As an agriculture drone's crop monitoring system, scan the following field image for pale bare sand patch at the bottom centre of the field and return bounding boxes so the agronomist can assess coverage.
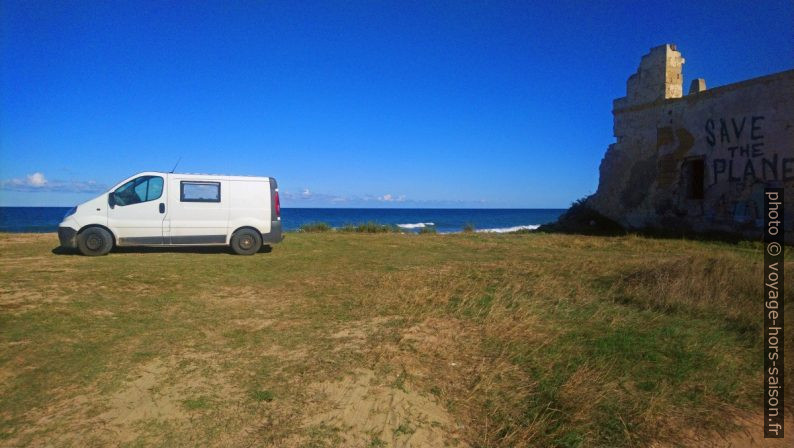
[286,316,470,447]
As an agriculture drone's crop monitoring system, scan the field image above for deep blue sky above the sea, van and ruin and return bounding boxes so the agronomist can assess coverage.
[0,0,794,207]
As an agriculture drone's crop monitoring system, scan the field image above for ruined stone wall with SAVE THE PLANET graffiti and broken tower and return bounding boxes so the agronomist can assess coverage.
[587,45,794,241]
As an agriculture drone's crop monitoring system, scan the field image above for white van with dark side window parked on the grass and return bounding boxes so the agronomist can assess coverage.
[58,172,283,255]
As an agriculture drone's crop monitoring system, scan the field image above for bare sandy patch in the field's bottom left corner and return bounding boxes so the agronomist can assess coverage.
[4,352,244,446]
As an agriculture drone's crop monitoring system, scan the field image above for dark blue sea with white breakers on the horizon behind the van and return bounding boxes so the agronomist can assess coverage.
[0,207,565,233]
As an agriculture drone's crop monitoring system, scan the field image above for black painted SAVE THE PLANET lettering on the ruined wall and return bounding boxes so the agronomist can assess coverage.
[704,115,794,184]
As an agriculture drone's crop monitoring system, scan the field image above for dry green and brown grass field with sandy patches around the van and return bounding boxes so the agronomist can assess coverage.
[0,232,794,447]
